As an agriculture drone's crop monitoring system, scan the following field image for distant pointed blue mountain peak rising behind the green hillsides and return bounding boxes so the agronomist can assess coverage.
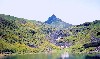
[44,14,72,29]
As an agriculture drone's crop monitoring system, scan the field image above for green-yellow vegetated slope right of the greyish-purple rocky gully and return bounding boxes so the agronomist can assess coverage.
[66,20,100,53]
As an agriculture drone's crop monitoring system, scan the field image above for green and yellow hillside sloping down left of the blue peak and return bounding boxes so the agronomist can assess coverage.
[0,14,59,53]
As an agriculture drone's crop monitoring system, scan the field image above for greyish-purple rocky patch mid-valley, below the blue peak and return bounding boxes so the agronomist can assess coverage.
[47,30,71,47]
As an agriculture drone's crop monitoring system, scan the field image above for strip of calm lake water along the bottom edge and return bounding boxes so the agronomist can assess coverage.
[1,53,100,59]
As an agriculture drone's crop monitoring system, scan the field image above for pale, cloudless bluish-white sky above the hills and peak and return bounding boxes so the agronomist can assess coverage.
[0,0,100,25]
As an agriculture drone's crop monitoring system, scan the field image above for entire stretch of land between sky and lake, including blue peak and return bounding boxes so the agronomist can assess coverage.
[0,14,100,53]
